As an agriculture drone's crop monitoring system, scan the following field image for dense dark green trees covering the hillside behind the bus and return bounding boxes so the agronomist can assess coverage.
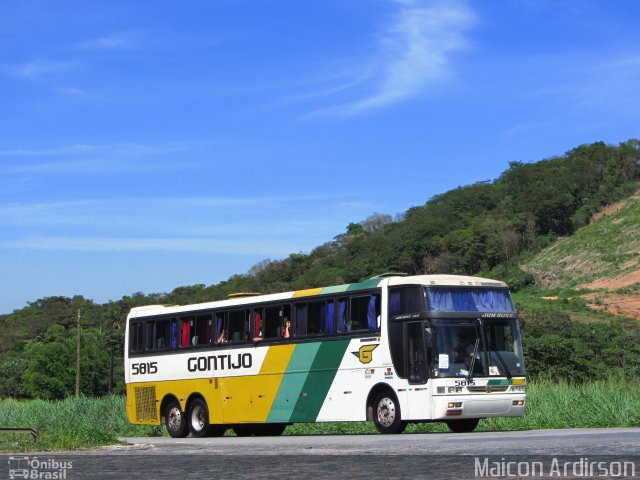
[0,140,640,398]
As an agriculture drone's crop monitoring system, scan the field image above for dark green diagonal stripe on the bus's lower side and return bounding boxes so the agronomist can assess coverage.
[290,340,349,422]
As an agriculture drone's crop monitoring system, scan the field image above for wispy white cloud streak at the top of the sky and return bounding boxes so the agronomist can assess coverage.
[312,0,474,116]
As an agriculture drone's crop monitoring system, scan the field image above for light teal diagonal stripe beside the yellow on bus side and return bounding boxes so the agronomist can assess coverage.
[267,342,321,423]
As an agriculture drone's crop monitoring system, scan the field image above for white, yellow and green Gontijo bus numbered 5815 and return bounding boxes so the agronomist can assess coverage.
[124,274,525,437]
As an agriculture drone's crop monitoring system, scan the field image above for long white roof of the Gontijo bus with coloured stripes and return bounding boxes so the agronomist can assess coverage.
[129,274,507,317]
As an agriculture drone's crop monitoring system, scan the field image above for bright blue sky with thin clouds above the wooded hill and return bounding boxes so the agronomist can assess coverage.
[0,0,640,313]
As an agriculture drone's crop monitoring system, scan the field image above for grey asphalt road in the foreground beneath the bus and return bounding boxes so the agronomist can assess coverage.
[0,428,640,480]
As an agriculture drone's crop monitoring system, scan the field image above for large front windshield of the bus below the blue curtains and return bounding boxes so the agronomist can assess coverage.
[432,319,525,377]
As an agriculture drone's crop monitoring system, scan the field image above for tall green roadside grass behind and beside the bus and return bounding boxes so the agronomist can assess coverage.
[0,378,640,452]
